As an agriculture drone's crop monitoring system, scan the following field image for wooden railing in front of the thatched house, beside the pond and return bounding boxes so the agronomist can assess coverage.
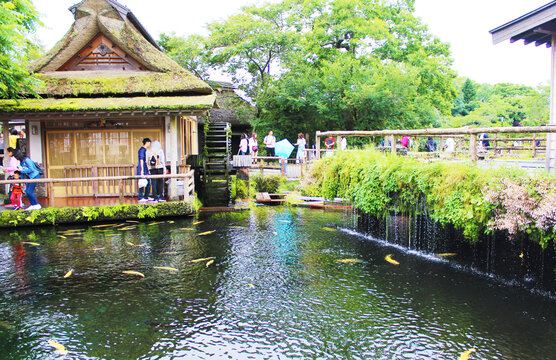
[0,170,195,205]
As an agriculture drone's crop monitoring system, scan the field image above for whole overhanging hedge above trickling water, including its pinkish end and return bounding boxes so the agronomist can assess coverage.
[302,149,556,246]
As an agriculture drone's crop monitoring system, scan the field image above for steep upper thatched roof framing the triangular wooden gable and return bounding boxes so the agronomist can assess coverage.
[30,0,212,97]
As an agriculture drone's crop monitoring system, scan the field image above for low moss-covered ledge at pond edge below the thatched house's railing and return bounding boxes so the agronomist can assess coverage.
[0,200,196,228]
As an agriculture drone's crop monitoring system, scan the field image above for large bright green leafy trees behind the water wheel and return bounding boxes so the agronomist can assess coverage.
[161,0,455,139]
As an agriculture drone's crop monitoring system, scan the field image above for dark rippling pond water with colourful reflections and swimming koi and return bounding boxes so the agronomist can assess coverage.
[0,208,556,360]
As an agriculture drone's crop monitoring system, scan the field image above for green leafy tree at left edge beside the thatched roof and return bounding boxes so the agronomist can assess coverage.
[0,0,38,98]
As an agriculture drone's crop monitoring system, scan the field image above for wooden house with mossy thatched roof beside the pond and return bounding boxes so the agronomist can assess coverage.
[0,0,215,197]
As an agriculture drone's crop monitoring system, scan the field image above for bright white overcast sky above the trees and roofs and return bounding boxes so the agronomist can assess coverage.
[34,0,551,86]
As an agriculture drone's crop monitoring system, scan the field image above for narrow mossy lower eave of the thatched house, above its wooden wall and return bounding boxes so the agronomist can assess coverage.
[0,95,215,113]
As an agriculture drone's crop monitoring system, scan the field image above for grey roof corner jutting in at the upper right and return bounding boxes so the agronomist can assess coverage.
[490,1,556,47]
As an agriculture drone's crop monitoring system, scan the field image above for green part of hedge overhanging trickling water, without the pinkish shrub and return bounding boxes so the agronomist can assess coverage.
[303,150,556,241]
